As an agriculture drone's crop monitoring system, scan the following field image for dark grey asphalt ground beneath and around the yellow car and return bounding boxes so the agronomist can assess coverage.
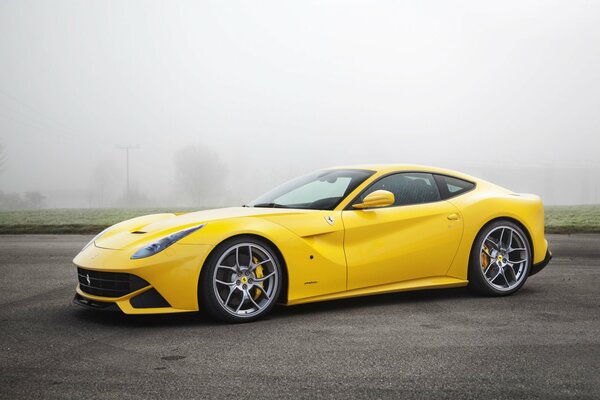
[0,235,600,400]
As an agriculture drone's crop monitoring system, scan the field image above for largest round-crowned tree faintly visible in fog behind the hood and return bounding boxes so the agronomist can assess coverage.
[175,145,227,205]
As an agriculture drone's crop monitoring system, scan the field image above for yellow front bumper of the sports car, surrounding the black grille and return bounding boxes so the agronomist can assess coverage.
[73,244,213,314]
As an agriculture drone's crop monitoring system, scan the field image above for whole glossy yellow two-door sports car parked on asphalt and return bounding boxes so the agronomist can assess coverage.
[73,165,552,322]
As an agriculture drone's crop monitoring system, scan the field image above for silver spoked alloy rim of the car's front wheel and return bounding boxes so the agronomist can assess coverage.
[213,243,279,317]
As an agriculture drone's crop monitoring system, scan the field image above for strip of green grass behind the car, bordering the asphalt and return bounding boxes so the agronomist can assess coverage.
[0,204,600,234]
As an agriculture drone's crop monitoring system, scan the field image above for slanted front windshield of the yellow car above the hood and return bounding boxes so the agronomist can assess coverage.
[247,169,373,210]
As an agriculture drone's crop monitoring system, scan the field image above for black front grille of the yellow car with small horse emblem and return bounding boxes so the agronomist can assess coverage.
[77,268,149,297]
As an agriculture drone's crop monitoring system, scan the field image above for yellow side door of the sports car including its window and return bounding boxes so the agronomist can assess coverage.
[342,172,463,290]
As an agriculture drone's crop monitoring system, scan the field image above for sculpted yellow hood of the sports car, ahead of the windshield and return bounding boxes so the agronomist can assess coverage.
[94,207,318,250]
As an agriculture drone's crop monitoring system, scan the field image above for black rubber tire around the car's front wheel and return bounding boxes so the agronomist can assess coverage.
[198,236,283,323]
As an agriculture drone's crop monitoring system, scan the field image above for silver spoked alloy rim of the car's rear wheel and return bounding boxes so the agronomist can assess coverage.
[479,225,529,292]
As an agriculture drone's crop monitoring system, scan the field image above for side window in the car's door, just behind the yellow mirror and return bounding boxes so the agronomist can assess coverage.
[356,172,441,206]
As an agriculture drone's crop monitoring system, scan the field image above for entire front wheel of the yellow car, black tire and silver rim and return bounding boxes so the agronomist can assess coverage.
[199,237,282,322]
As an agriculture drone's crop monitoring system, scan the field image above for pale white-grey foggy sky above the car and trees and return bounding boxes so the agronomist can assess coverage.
[0,0,600,207]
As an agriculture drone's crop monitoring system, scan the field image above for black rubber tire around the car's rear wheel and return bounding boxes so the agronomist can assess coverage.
[468,220,533,296]
